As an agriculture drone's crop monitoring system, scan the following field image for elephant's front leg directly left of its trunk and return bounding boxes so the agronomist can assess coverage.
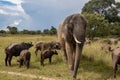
[65,42,74,74]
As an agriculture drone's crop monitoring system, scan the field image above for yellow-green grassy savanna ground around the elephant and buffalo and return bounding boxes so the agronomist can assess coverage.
[0,35,120,80]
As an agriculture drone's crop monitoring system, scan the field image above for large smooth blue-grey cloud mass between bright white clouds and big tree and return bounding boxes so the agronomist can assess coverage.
[22,0,88,30]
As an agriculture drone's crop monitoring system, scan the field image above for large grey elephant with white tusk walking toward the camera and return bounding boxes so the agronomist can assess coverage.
[58,14,86,80]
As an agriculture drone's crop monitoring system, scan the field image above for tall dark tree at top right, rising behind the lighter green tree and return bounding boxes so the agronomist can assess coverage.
[82,0,120,23]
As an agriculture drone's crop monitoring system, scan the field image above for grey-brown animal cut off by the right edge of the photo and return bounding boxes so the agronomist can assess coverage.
[111,47,120,78]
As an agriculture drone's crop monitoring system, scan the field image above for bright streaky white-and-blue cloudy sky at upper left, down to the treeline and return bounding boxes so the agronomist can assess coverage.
[0,0,31,29]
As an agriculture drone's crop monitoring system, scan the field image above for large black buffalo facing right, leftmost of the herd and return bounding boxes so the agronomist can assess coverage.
[5,42,33,66]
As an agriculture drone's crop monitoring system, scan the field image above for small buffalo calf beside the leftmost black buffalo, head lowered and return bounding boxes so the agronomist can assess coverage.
[18,50,31,69]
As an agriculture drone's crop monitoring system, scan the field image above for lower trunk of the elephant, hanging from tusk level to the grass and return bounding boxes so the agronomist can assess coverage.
[73,43,83,80]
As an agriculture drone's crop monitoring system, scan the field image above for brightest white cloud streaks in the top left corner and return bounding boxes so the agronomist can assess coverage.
[0,0,30,19]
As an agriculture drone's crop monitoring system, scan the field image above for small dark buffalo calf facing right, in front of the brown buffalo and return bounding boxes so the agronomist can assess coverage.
[40,50,58,66]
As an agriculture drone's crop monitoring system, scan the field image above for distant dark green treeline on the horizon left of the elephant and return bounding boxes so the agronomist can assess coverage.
[0,26,57,35]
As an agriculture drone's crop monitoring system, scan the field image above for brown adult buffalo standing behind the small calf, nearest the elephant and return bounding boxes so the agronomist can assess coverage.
[35,41,61,56]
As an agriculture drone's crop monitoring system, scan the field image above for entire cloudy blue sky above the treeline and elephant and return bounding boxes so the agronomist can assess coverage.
[0,0,89,30]
